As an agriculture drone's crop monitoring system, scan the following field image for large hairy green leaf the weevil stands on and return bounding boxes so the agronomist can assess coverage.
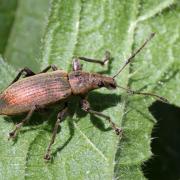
[0,0,180,179]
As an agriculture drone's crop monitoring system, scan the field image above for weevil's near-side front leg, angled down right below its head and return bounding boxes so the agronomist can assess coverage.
[81,99,122,135]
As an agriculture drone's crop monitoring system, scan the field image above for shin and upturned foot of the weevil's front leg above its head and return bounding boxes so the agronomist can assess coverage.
[74,51,111,65]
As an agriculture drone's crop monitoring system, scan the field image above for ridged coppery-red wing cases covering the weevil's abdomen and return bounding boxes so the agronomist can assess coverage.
[0,70,71,115]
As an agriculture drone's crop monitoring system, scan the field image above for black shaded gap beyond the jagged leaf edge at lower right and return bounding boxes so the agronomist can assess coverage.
[142,101,180,180]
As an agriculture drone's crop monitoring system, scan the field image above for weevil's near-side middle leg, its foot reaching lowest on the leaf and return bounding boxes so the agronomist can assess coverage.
[44,105,68,160]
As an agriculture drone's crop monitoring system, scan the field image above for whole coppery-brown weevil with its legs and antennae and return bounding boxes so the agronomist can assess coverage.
[0,33,166,160]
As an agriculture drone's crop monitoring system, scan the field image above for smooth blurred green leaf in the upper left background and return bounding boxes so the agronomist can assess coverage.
[0,0,49,71]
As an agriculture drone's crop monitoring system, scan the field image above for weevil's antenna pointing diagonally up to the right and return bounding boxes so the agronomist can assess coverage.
[113,33,155,79]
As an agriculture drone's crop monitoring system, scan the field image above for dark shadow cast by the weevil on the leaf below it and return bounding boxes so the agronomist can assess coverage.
[5,92,121,160]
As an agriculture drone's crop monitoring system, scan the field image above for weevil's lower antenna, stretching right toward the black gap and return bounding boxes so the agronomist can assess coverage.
[118,85,168,103]
